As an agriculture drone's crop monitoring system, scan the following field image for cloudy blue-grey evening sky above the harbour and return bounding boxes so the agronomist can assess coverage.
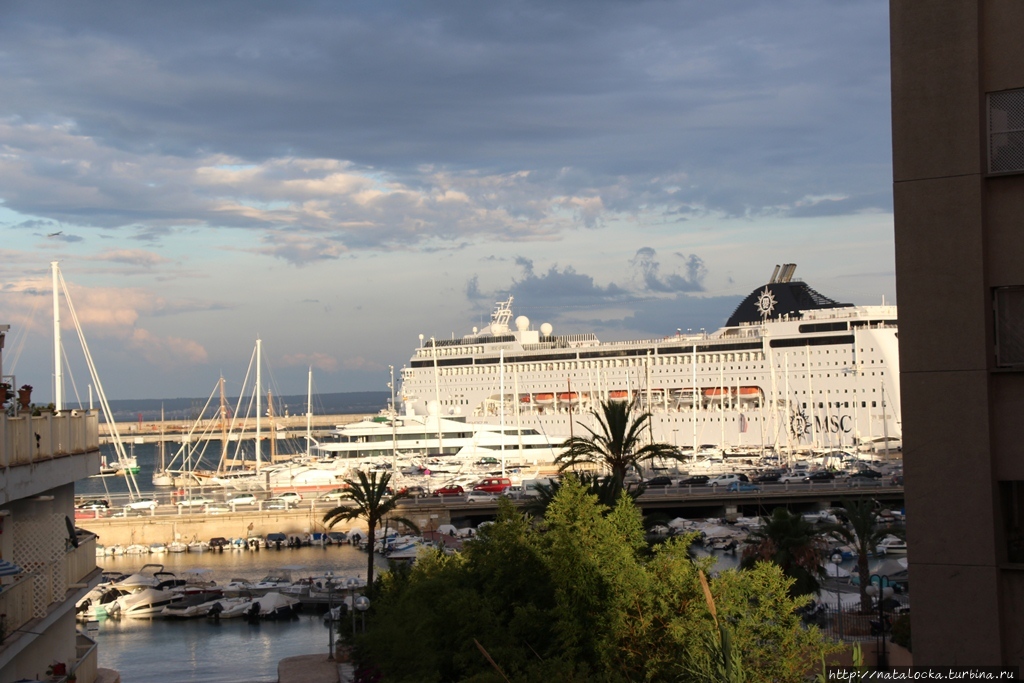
[0,0,895,401]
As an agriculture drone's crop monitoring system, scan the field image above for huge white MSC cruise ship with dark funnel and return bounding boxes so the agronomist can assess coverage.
[397,263,901,456]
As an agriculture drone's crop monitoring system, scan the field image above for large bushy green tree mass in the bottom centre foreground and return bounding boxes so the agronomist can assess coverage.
[359,477,831,683]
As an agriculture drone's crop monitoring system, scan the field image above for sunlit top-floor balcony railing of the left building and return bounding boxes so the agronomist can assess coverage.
[0,411,99,467]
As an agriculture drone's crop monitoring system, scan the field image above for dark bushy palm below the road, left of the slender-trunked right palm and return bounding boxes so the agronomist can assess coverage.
[739,508,825,597]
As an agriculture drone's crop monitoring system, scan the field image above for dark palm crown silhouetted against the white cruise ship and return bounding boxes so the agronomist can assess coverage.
[555,400,679,488]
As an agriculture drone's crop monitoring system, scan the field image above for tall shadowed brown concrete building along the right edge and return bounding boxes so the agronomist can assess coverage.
[890,0,1024,667]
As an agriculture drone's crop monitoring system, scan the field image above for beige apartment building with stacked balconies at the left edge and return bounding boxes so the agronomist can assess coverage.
[0,326,100,683]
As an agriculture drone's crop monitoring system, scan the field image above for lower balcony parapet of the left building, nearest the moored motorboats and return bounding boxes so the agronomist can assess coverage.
[0,536,96,647]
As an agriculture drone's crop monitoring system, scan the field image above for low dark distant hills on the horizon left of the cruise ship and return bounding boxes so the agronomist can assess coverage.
[97,391,391,422]
